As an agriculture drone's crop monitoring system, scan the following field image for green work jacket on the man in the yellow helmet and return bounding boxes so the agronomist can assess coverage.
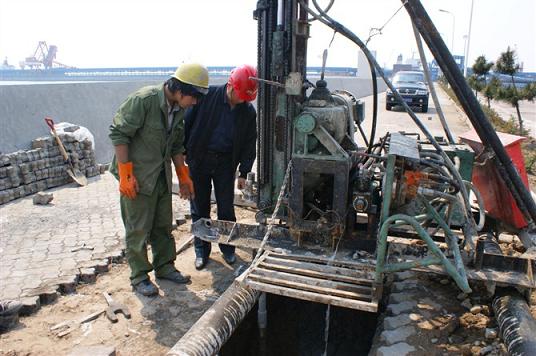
[109,84,185,195]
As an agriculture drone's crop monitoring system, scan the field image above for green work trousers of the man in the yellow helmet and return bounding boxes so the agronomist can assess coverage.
[121,173,177,285]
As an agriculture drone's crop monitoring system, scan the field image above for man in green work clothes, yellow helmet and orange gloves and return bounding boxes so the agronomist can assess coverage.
[109,63,208,296]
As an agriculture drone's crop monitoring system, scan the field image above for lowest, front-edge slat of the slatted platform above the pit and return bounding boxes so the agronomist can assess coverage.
[246,280,378,313]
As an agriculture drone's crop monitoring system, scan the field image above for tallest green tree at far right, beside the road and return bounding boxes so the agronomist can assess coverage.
[495,46,524,134]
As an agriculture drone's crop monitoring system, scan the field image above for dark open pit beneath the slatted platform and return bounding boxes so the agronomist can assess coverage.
[219,294,378,356]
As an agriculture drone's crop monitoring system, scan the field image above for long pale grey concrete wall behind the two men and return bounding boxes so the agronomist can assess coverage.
[0,77,385,163]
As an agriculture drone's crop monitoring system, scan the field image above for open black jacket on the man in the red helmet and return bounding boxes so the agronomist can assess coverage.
[184,84,257,178]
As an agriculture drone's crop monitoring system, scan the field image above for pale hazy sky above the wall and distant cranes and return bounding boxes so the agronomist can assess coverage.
[0,0,536,72]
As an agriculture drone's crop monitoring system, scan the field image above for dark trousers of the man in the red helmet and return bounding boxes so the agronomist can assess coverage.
[190,153,236,258]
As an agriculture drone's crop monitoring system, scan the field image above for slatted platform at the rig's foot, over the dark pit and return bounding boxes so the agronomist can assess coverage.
[241,251,381,313]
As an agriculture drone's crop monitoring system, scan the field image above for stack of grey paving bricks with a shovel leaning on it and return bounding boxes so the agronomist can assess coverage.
[0,134,106,204]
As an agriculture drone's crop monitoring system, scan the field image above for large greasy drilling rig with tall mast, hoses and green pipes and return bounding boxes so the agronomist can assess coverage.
[172,0,536,355]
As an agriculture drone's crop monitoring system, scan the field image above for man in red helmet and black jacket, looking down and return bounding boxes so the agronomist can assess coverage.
[184,65,257,270]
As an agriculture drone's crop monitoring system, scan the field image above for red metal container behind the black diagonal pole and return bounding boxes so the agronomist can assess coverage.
[460,130,529,229]
